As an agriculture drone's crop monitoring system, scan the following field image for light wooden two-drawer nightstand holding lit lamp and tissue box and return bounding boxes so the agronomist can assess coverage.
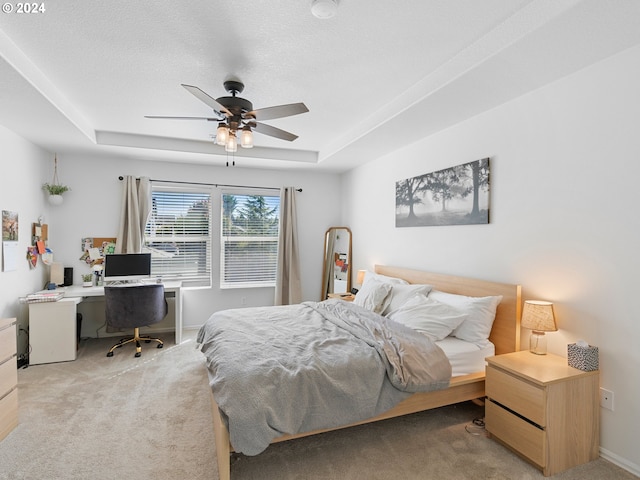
[485,351,600,476]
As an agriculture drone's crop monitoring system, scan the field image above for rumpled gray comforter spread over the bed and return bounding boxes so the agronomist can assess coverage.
[198,300,451,455]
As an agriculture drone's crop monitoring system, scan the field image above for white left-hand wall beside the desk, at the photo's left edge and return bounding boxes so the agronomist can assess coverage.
[0,126,53,353]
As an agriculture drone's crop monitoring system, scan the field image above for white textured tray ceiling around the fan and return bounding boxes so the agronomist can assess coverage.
[0,0,640,171]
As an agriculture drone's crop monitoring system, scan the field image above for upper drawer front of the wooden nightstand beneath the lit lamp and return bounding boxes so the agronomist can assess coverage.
[485,365,546,427]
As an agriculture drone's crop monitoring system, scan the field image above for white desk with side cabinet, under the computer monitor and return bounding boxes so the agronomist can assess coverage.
[29,282,182,365]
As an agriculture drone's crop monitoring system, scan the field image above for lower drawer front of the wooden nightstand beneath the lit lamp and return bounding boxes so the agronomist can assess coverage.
[485,401,546,467]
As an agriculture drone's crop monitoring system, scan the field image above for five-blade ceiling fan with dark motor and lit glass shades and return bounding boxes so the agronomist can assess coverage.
[145,80,309,152]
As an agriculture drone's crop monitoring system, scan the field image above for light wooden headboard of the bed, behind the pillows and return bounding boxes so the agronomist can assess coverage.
[375,265,522,355]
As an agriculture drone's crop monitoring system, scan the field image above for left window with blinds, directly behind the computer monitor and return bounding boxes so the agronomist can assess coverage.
[145,186,211,285]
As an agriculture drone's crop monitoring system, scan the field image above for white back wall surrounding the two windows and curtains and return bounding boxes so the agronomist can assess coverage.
[45,154,341,336]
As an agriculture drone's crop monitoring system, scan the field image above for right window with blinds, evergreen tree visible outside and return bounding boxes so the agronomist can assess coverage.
[220,193,280,288]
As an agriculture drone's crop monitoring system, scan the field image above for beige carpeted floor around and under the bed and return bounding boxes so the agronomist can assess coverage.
[0,332,637,480]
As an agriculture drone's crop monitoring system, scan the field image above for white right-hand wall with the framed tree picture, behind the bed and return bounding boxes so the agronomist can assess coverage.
[343,47,640,474]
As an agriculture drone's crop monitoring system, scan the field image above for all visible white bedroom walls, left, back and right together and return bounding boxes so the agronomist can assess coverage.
[0,36,640,474]
